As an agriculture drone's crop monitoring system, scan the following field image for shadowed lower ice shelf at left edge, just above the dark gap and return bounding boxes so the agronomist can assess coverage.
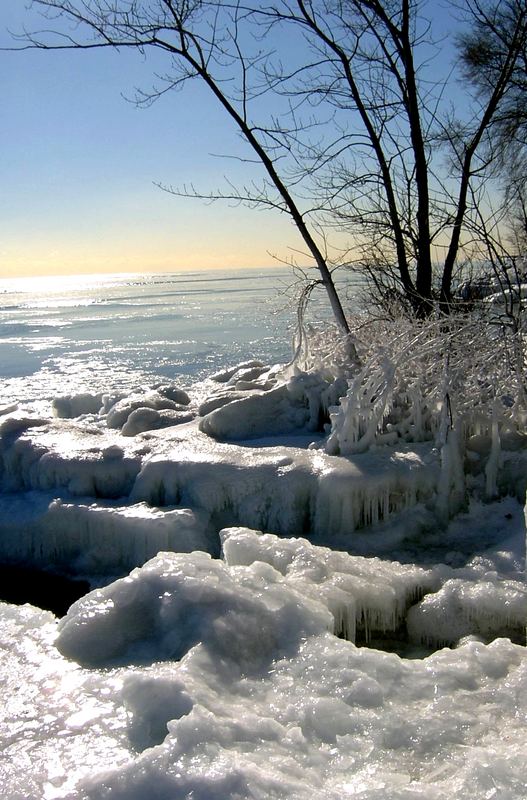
[0,492,212,577]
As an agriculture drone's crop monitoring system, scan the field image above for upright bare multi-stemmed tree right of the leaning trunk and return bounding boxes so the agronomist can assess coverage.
[245,0,527,317]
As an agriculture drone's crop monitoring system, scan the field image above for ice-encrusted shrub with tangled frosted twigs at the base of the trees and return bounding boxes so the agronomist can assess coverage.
[300,308,527,495]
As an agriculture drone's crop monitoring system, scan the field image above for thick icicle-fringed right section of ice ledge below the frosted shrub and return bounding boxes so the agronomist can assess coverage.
[130,431,438,538]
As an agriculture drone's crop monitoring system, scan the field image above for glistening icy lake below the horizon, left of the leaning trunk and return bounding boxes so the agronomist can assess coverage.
[0,269,300,404]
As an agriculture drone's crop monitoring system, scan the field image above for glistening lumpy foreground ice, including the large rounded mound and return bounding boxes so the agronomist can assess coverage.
[0,530,527,800]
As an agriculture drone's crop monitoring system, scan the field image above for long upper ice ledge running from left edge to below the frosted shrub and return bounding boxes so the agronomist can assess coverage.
[0,412,437,537]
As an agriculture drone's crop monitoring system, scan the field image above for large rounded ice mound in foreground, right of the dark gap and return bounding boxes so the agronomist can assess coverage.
[57,552,331,671]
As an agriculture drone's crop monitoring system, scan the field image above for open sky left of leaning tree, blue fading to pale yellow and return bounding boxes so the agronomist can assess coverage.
[0,0,462,277]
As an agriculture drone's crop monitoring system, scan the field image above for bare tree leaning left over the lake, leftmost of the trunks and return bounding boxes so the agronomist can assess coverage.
[13,0,368,362]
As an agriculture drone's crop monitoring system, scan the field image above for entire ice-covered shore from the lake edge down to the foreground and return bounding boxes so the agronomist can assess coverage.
[0,362,527,800]
